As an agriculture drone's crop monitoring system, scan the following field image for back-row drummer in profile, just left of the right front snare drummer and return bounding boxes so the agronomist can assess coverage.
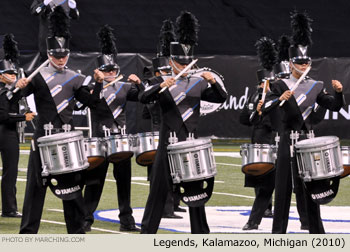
[239,37,276,230]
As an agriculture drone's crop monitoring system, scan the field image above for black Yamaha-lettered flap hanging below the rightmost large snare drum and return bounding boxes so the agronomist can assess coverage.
[304,176,340,205]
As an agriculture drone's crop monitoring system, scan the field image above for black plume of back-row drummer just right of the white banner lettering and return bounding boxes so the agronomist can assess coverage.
[255,37,277,71]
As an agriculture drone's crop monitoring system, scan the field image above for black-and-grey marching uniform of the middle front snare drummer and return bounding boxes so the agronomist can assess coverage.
[140,74,226,233]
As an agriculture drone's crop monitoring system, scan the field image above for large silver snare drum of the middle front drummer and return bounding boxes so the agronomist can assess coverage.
[167,139,216,184]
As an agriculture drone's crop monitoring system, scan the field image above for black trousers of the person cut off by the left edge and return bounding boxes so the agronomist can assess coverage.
[0,129,19,214]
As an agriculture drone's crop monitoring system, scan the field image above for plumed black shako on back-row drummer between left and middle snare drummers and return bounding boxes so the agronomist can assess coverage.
[97,24,119,72]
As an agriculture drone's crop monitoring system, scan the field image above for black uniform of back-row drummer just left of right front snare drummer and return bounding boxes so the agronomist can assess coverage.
[239,88,277,226]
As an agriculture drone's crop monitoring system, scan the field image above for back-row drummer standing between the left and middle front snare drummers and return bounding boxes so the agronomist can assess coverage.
[84,25,141,232]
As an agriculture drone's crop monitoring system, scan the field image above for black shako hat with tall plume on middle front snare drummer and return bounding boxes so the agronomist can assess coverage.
[170,11,199,65]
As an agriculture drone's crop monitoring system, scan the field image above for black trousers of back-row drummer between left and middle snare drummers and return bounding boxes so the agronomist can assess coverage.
[84,159,135,226]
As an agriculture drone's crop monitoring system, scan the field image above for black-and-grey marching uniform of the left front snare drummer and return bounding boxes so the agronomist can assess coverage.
[20,64,101,234]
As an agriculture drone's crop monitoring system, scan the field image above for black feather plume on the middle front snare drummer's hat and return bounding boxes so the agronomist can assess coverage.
[176,11,199,46]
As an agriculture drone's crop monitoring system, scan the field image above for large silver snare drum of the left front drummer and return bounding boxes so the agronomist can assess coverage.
[38,131,89,176]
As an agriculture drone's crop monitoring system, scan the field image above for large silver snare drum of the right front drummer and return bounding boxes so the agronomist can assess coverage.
[295,136,344,182]
